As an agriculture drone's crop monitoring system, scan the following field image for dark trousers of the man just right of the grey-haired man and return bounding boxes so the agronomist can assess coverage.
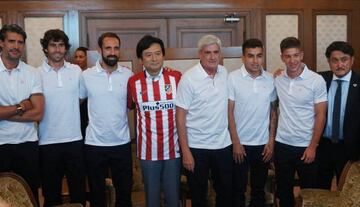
[233,145,269,207]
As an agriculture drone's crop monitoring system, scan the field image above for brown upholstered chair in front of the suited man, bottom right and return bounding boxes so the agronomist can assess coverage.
[301,161,360,207]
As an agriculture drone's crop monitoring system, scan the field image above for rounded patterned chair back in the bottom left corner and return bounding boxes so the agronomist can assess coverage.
[0,172,37,207]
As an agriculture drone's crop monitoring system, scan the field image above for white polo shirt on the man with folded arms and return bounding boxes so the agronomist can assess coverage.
[0,57,42,145]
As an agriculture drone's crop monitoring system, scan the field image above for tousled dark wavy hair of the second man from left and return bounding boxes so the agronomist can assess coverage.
[40,29,71,54]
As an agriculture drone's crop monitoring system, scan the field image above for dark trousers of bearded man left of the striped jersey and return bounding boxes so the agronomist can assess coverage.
[85,143,132,207]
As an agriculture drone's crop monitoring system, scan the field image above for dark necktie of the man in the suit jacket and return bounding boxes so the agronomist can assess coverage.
[331,80,342,143]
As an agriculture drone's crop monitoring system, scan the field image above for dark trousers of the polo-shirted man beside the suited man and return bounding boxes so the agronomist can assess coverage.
[274,142,318,207]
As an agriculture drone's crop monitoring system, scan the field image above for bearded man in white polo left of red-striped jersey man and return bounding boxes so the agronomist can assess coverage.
[80,32,133,206]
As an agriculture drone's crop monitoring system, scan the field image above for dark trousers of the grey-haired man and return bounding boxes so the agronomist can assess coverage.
[186,146,232,207]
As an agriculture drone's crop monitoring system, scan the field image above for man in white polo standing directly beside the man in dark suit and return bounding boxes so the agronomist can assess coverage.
[274,37,327,207]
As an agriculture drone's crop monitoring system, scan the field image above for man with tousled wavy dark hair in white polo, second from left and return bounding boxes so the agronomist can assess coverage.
[39,29,85,206]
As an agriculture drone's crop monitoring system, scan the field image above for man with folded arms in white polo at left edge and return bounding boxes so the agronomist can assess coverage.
[0,24,44,201]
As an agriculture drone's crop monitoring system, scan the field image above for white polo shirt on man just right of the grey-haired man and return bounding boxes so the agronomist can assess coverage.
[228,65,276,146]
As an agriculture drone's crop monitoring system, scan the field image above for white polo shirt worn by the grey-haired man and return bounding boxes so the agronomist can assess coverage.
[175,63,231,149]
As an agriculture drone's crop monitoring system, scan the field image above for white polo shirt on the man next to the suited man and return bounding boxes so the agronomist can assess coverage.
[275,66,327,147]
